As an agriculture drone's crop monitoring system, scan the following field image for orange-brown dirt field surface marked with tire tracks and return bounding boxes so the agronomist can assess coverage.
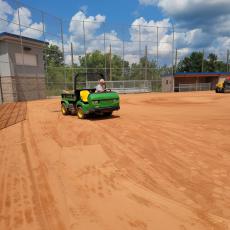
[0,92,230,230]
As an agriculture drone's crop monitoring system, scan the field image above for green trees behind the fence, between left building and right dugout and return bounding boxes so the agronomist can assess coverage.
[44,44,172,84]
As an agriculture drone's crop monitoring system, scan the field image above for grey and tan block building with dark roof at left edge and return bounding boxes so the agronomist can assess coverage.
[0,33,48,103]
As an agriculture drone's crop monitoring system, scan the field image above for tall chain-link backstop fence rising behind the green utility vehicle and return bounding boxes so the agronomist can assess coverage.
[0,0,228,101]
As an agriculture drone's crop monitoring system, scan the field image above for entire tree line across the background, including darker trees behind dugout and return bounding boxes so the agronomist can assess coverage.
[44,44,227,92]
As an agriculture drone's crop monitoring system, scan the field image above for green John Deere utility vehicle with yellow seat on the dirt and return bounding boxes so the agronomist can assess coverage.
[61,73,120,119]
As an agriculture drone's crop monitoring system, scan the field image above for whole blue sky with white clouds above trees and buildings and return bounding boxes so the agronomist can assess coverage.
[0,0,230,64]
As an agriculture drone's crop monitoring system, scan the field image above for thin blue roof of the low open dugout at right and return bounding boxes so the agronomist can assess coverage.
[162,72,230,77]
